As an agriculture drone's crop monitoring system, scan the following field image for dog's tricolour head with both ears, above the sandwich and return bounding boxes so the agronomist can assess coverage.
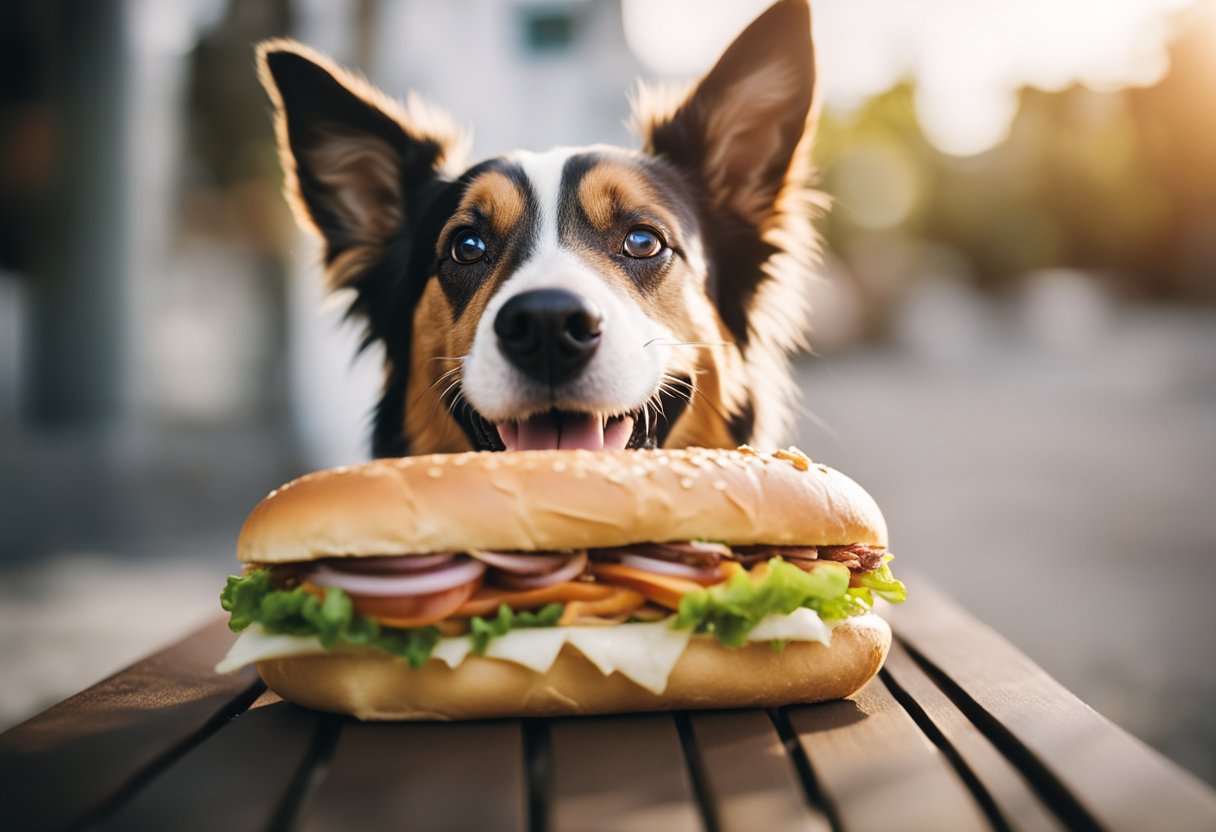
[259,0,815,456]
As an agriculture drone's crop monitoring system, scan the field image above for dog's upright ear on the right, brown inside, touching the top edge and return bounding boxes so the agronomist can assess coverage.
[635,0,815,227]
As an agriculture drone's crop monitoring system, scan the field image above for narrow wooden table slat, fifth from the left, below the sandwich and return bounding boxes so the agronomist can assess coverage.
[689,710,832,832]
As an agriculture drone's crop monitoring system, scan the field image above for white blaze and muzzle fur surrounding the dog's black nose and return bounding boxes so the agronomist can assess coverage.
[462,147,671,421]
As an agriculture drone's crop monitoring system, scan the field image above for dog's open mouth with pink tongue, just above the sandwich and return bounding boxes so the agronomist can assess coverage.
[456,379,687,451]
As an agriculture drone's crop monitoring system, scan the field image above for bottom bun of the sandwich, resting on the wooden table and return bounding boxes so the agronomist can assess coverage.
[258,614,891,720]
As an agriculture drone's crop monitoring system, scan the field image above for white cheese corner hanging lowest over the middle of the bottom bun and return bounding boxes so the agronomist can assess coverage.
[563,620,692,693]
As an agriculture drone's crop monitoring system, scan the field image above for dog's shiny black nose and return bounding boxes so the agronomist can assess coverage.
[494,288,603,384]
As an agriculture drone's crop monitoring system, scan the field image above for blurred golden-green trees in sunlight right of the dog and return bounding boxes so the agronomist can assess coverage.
[815,8,1216,337]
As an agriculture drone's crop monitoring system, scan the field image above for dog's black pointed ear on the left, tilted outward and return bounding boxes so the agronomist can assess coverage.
[258,40,467,288]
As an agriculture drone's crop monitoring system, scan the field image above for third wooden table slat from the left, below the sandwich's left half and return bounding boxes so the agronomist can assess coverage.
[298,720,527,832]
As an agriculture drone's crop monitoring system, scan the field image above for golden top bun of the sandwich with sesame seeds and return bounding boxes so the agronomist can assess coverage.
[237,446,886,563]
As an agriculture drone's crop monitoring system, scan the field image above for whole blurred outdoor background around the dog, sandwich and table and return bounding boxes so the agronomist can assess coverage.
[0,0,1216,783]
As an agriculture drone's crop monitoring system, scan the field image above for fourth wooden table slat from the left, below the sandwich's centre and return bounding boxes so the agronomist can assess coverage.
[548,714,702,832]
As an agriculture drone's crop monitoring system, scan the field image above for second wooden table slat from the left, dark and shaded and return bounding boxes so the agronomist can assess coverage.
[98,702,326,832]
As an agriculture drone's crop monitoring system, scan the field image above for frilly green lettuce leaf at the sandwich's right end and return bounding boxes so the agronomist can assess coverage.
[672,557,905,647]
